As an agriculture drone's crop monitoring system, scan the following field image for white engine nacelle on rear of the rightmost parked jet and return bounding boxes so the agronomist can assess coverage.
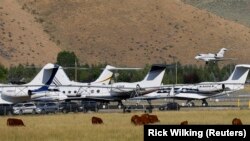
[197,84,225,93]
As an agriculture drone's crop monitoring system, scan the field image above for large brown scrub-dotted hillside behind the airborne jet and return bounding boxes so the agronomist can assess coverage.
[1,0,250,67]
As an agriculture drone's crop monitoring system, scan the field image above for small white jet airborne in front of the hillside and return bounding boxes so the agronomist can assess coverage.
[195,48,232,64]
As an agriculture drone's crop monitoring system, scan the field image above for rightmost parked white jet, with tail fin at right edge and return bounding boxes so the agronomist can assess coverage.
[131,64,250,106]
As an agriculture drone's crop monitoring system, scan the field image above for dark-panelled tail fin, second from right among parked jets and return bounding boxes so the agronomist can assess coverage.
[141,65,166,86]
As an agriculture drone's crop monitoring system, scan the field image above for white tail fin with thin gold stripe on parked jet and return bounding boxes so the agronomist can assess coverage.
[92,65,115,85]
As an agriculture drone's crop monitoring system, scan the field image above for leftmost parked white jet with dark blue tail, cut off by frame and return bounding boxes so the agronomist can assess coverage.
[0,63,61,104]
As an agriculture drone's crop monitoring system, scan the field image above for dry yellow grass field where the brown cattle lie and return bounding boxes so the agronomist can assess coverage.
[0,110,250,141]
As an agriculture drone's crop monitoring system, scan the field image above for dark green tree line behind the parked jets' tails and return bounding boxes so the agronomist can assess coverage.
[0,51,239,84]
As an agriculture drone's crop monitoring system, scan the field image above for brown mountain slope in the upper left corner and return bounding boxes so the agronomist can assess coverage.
[0,0,61,66]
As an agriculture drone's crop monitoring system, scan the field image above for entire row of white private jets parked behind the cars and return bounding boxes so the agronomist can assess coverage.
[0,64,250,106]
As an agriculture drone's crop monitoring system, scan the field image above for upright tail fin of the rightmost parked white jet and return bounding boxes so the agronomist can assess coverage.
[224,64,250,84]
